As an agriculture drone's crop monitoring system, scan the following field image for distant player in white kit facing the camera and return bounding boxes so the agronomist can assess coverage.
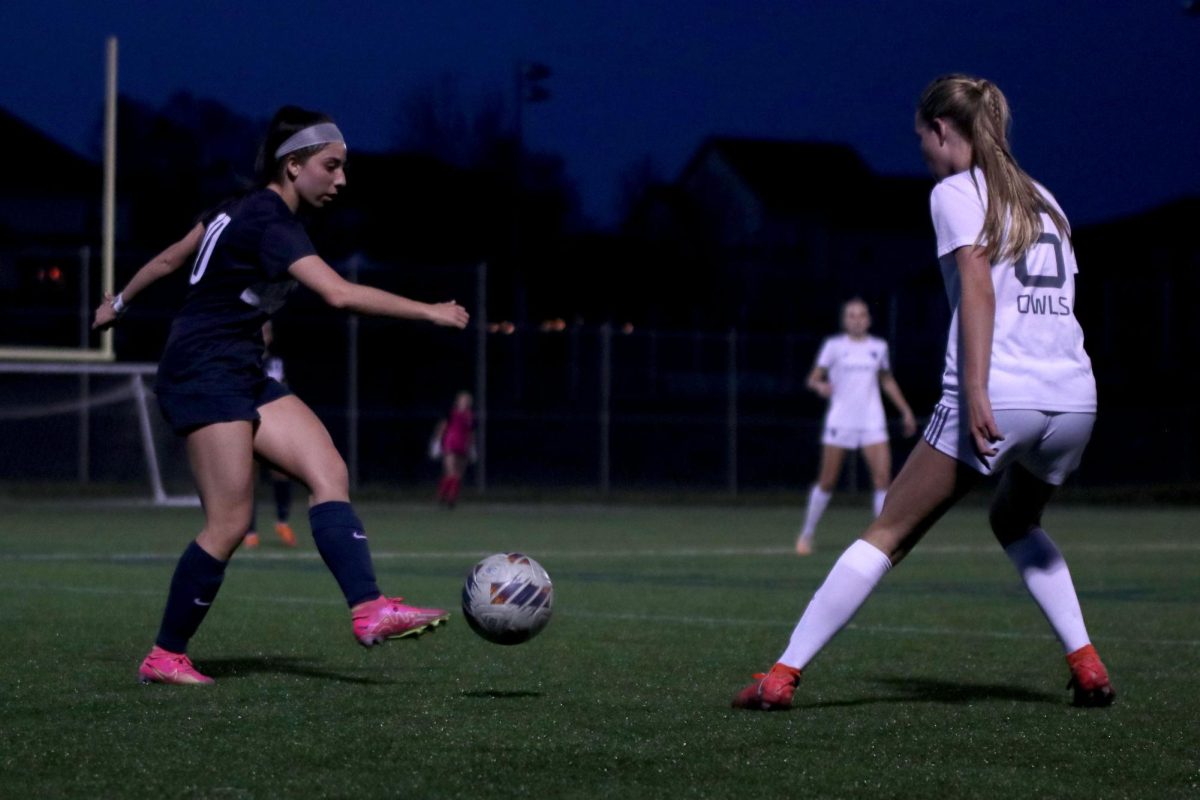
[796,297,917,555]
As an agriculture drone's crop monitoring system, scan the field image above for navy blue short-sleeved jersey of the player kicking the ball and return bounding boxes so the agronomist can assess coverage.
[157,188,317,395]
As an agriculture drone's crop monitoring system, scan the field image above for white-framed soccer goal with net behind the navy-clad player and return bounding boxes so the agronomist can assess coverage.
[0,361,198,505]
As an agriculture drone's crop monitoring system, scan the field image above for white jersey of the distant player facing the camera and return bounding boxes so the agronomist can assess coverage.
[817,333,892,429]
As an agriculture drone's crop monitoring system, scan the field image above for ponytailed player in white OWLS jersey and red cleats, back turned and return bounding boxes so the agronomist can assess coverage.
[733,74,1115,710]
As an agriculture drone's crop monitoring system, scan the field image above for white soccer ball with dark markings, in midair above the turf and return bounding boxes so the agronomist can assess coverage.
[462,553,554,644]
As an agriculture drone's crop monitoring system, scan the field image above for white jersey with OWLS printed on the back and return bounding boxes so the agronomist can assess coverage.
[929,168,1096,411]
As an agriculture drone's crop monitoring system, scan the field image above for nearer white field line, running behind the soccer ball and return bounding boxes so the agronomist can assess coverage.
[0,582,1200,648]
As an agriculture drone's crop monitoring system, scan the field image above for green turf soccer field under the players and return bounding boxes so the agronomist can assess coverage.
[0,500,1200,799]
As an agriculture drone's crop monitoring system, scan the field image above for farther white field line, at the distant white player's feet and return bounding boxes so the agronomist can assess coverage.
[0,537,1200,563]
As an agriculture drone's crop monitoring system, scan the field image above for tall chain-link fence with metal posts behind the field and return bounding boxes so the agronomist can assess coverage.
[0,262,1200,494]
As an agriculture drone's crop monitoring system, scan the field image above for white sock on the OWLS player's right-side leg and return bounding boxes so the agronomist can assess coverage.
[1004,528,1091,652]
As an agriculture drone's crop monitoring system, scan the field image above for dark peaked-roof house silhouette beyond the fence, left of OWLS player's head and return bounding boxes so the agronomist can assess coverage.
[626,137,936,332]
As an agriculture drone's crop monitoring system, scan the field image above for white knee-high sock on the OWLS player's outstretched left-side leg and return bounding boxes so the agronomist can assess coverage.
[779,539,892,669]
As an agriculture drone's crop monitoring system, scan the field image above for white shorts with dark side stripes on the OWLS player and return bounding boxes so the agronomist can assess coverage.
[925,403,1096,486]
